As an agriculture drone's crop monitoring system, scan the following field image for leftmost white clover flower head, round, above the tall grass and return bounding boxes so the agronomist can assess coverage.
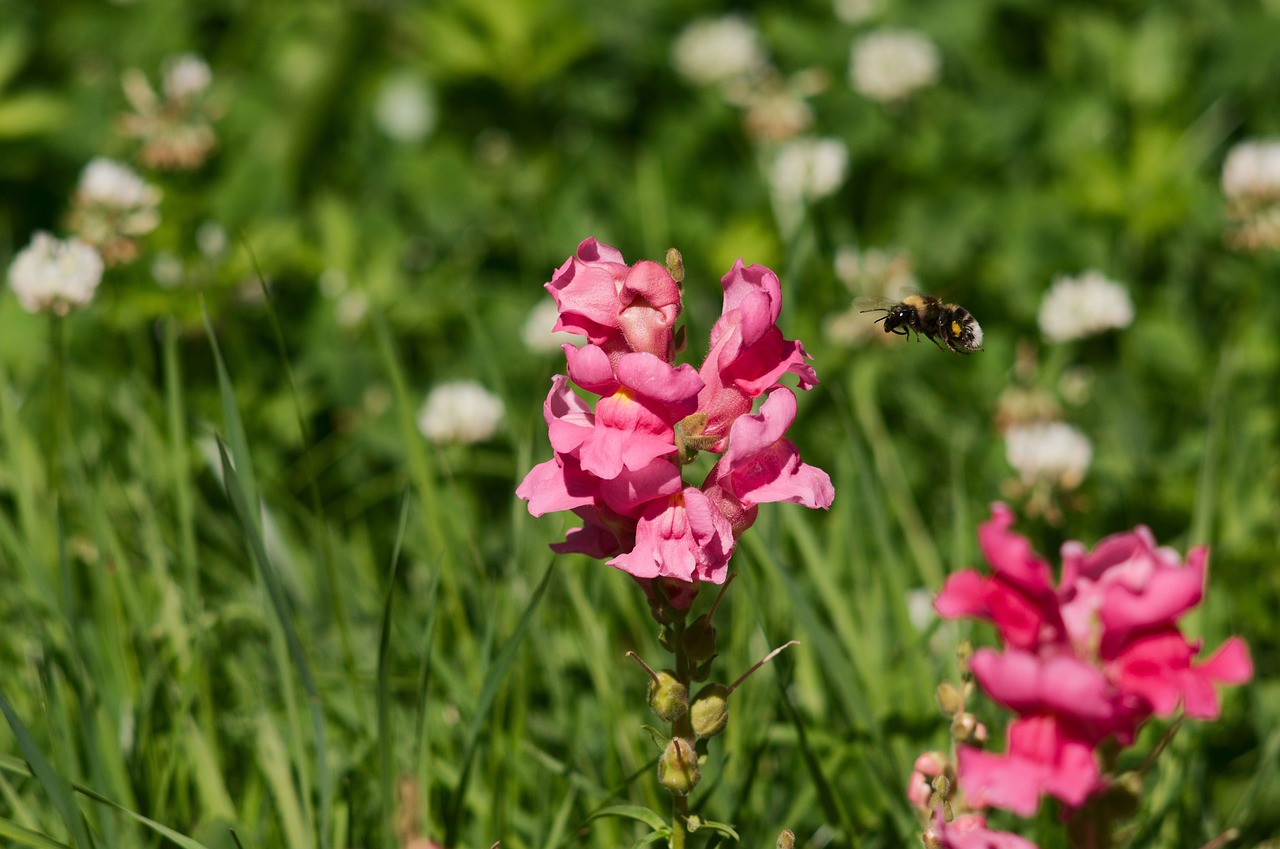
[9,233,102,315]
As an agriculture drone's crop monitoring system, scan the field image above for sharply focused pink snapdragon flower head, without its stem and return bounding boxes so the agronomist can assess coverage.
[516,238,833,607]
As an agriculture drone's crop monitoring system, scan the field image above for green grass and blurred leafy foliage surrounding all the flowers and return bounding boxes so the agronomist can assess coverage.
[0,0,1280,849]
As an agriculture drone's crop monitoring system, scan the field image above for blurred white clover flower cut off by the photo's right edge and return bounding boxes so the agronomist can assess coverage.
[1222,138,1280,251]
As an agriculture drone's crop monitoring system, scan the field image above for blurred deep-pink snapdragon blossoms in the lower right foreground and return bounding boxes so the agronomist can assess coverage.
[934,505,1253,816]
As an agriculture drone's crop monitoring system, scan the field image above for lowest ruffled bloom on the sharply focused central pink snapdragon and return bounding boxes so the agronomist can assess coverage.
[609,487,733,584]
